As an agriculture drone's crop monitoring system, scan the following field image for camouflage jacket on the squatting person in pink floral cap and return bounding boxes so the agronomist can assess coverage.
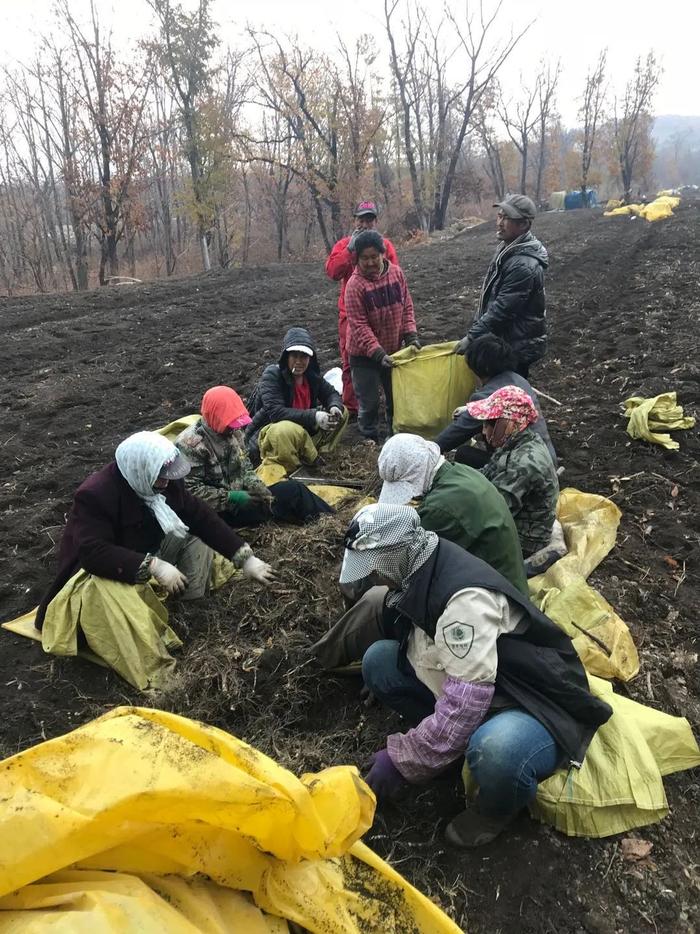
[482,428,559,558]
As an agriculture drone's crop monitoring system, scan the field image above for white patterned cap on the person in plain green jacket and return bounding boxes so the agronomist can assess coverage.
[377,434,445,504]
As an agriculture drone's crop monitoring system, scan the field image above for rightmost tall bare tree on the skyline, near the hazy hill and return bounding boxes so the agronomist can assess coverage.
[613,52,661,201]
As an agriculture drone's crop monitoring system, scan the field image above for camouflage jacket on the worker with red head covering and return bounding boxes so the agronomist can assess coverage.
[175,418,272,512]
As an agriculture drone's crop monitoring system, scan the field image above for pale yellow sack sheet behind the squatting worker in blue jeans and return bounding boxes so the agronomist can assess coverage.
[532,677,700,837]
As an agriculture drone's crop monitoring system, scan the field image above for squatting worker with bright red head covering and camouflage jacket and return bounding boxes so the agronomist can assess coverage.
[175,386,333,528]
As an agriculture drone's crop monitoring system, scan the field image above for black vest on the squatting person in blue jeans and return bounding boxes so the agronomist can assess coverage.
[394,538,612,766]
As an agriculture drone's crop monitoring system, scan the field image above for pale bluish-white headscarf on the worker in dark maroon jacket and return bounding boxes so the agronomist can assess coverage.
[115,431,188,538]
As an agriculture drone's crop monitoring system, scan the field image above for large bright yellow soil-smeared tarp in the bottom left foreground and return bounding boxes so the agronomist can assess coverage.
[0,707,459,934]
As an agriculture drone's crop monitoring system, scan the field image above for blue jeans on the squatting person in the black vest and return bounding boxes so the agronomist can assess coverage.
[362,639,562,818]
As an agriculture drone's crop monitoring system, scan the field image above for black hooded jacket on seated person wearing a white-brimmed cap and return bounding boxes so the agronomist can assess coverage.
[245,328,343,454]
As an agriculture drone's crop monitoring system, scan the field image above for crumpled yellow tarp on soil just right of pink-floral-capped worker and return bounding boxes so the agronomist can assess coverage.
[528,488,639,681]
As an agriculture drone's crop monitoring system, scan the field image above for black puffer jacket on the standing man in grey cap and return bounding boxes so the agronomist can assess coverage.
[469,231,549,364]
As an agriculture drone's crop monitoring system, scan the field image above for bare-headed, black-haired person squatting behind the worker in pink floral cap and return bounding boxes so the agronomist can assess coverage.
[435,334,558,467]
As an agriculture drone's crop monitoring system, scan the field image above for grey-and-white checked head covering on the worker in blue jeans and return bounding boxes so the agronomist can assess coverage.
[340,503,439,606]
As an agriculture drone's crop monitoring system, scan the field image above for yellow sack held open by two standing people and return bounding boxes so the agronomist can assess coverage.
[391,341,476,439]
